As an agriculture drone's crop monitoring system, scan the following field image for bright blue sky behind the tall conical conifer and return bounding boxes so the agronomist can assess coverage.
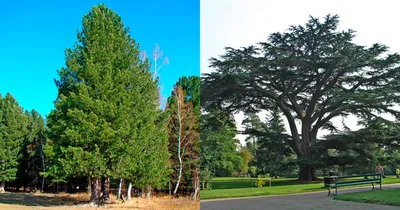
[0,0,200,116]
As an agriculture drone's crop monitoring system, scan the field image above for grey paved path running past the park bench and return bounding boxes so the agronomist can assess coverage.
[200,184,400,210]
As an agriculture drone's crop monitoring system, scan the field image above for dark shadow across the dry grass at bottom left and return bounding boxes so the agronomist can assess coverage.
[0,192,88,207]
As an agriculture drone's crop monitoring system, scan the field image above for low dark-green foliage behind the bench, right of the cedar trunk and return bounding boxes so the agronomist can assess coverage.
[315,117,400,173]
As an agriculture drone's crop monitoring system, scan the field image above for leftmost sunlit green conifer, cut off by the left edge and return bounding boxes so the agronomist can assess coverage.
[0,93,27,193]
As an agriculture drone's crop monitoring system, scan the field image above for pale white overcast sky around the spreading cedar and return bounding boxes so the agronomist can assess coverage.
[200,0,400,143]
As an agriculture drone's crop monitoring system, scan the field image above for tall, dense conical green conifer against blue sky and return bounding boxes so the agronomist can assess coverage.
[46,4,168,202]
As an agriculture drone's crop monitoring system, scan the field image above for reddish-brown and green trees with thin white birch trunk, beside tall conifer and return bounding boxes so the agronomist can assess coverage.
[166,76,200,198]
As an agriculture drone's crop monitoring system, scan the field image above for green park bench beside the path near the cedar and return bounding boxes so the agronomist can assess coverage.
[324,174,382,196]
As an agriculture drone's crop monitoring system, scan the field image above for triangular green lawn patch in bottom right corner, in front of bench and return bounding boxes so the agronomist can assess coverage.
[334,189,400,206]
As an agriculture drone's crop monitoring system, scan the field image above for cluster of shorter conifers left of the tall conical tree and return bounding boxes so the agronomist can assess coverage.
[0,93,45,191]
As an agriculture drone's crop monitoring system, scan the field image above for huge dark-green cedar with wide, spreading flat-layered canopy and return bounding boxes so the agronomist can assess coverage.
[201,15,400,180]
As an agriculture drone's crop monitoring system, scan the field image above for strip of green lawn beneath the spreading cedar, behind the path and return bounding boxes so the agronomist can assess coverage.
[200,176,400,200]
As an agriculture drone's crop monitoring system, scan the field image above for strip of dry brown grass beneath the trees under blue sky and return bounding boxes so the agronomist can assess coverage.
[0,193,200,210]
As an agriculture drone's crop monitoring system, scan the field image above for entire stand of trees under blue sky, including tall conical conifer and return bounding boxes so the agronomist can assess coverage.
[0,4,200,202]
